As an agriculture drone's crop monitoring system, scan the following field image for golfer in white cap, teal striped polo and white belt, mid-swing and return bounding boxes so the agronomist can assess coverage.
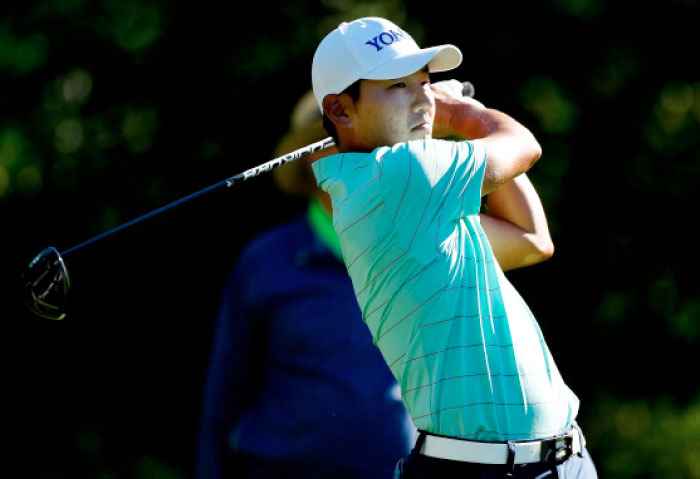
[312,18,597,478]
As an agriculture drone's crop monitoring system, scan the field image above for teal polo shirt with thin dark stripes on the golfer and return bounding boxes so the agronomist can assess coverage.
[313,139,578,441]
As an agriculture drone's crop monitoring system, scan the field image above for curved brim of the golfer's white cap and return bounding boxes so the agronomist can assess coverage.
[362,45,462,80]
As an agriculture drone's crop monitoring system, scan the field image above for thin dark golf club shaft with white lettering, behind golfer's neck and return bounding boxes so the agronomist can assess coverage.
[59,137,335,256]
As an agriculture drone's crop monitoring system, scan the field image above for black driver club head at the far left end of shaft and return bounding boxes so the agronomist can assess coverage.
[22,246,70,319]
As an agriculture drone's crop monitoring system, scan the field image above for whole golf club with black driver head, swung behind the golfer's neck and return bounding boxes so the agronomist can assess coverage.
[21,80,474,320]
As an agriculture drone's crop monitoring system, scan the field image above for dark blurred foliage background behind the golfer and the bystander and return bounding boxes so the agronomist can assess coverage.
[0,0,700,479]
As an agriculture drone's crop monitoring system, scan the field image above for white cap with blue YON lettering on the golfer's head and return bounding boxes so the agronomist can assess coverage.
[311,17,462,111]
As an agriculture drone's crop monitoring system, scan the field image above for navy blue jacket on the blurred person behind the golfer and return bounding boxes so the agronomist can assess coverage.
[197,215,415,479]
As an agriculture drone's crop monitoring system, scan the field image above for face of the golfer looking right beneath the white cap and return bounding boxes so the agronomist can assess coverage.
[351,69,435,151]
